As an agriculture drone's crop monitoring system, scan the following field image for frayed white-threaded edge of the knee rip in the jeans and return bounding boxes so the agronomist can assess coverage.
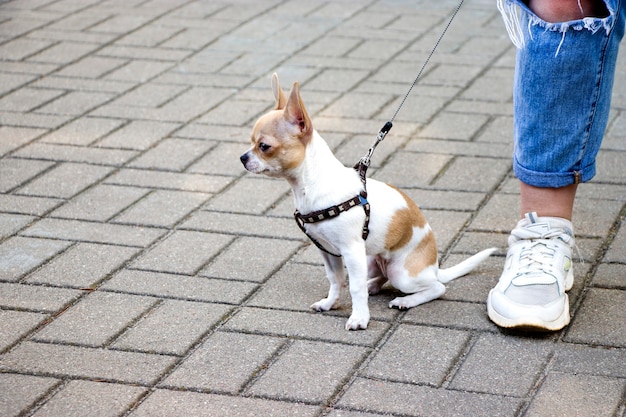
[497,0,619,56]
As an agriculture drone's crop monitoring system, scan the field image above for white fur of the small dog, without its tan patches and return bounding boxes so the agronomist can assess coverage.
[241,76,495,330]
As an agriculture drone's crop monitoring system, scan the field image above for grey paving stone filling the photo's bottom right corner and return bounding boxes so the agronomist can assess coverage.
[526,373,626,417]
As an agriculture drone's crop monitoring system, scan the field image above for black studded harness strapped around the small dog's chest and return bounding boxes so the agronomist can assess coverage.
[293,162,370,257]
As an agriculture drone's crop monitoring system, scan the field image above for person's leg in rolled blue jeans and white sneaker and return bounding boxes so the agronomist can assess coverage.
[487,0,625,330]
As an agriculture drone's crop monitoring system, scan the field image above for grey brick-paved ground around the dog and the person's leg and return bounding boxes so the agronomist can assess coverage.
[0,0,626,417]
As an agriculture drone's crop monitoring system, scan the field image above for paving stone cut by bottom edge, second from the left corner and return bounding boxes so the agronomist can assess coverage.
[33,381,146,417]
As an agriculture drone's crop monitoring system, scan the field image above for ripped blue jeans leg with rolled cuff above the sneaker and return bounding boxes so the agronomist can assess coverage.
[498,0,626,188]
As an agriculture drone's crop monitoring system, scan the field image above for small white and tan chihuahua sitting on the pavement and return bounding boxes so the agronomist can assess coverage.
[240,74,495,330]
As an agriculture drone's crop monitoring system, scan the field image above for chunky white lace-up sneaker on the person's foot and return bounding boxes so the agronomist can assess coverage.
[487,213,574,330]
